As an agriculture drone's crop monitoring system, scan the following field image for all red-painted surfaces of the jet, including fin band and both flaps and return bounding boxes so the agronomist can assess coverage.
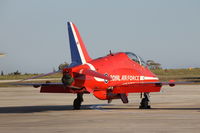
[41,24,162,100]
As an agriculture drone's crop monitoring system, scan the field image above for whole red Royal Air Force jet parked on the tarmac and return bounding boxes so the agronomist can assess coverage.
[19,22,195,109]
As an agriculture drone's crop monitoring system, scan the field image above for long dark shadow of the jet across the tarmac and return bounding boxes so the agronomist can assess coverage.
[0,104,200,114]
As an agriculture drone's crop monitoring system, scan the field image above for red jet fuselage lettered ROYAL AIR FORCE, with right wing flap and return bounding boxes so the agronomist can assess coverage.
[61,52,161,100]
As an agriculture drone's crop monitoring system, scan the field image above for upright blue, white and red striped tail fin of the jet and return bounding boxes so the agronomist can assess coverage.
[67,22,91,67]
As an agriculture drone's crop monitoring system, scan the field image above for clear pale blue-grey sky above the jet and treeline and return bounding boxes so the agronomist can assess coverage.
[0,0,200,73]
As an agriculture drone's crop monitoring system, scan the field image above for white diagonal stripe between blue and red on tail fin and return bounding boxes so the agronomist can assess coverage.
[70,22,86,64]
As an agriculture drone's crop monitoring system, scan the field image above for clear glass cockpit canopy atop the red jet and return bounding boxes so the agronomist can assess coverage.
[125,52,147,67]
